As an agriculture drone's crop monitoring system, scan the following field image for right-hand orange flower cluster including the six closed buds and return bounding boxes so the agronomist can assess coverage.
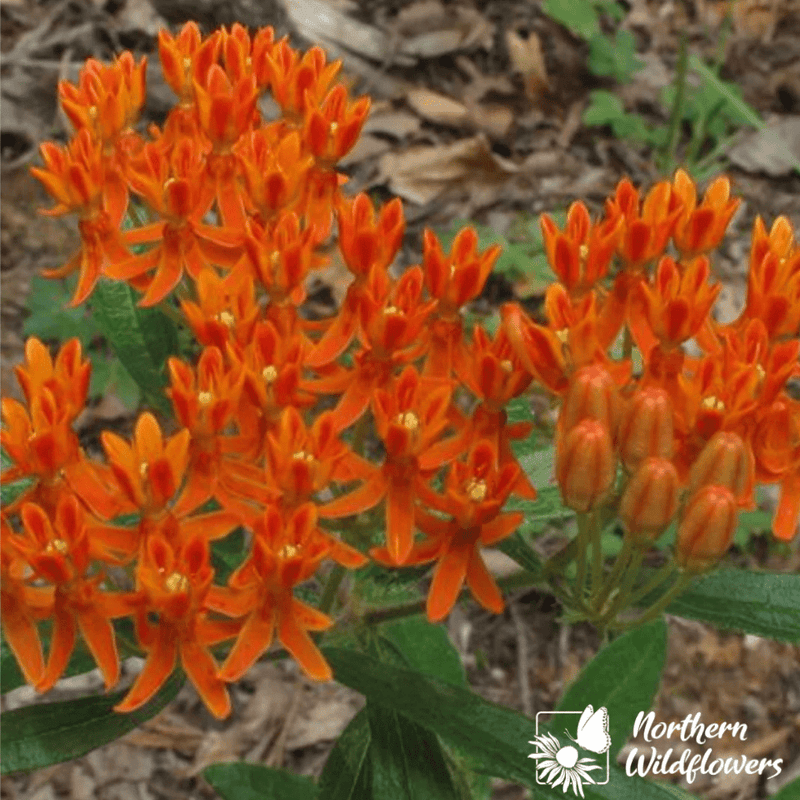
[503,170,800,570]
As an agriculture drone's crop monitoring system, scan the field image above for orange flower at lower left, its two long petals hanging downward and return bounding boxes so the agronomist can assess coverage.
[12,495,129,692]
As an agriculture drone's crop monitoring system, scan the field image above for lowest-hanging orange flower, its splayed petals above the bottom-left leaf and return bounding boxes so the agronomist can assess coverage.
[114,534,237,719]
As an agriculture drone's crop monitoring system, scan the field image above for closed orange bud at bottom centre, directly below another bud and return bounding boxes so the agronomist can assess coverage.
[619,458,680,545]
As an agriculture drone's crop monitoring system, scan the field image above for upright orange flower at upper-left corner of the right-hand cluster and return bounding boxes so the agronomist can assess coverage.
[539,202,622,298]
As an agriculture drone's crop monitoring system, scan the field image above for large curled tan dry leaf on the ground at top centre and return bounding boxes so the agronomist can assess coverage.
[380,134,518,205]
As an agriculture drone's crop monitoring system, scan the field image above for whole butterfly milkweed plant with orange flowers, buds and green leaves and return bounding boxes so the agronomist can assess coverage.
[2,23,800,800]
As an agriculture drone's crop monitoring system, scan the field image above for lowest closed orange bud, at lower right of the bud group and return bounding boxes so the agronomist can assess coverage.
[675,486,738,572]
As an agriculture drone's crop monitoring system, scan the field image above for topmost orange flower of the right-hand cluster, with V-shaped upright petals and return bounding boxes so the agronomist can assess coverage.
[672,169,741,261]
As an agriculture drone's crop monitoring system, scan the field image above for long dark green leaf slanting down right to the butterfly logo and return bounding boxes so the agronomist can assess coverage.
[320,648,684,800]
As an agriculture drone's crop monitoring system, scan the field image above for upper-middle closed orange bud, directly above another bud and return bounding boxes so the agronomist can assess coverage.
[618,388,675,472]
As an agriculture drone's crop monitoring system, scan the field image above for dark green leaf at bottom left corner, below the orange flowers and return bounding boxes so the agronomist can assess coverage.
[0,671,184,775]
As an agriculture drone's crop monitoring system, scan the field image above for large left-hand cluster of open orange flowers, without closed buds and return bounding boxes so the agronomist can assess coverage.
[2,24,535,717]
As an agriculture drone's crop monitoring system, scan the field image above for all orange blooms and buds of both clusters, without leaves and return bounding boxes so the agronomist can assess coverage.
[1,24,800,717]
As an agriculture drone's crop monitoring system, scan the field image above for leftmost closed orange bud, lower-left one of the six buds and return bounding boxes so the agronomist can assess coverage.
[556,419,616,512]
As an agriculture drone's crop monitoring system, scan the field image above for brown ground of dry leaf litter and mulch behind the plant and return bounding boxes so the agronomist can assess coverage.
[0,0,800,800]
